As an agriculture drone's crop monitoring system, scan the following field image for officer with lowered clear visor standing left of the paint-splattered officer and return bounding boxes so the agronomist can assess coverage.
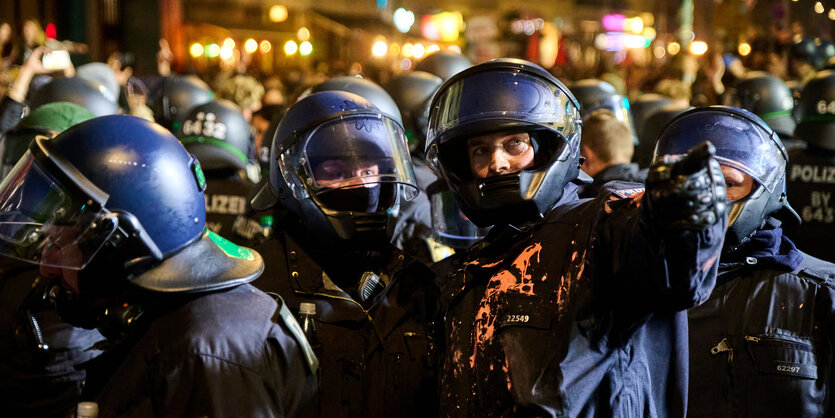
[252,91,439,417]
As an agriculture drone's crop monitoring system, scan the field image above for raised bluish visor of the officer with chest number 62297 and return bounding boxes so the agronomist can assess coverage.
[654,111,786,192]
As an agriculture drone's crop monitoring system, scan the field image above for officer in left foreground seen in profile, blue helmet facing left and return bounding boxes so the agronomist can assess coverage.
[0,116,316,416]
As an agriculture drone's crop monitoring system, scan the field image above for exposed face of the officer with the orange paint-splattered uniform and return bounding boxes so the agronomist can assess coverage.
[467,132,534,179]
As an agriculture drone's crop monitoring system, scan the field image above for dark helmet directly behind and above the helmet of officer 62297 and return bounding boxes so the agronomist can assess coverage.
[723,71,795,138]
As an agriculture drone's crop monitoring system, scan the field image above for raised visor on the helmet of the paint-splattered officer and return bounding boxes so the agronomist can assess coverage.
[427,70,581,146]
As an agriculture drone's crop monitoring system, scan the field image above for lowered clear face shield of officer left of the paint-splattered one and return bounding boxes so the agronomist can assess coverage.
[279,114,419,213]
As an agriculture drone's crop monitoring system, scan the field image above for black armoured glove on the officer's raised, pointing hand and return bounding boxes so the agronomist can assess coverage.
[645,141,728,231]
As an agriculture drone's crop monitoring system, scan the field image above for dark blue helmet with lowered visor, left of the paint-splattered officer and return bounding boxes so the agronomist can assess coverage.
[252,91,418,248]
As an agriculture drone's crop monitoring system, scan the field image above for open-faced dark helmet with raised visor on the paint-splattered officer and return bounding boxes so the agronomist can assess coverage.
[426,59,588,227]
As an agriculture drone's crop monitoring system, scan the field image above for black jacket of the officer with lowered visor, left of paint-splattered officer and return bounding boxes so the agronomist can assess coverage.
[254,232,440,418]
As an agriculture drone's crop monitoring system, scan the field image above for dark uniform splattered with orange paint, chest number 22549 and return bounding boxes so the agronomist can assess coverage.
[441,183,724,417]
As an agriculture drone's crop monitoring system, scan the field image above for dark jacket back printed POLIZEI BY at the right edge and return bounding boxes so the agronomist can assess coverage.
[786,147,835,262]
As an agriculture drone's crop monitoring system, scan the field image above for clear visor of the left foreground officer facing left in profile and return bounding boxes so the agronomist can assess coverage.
[0,151,117,270]
